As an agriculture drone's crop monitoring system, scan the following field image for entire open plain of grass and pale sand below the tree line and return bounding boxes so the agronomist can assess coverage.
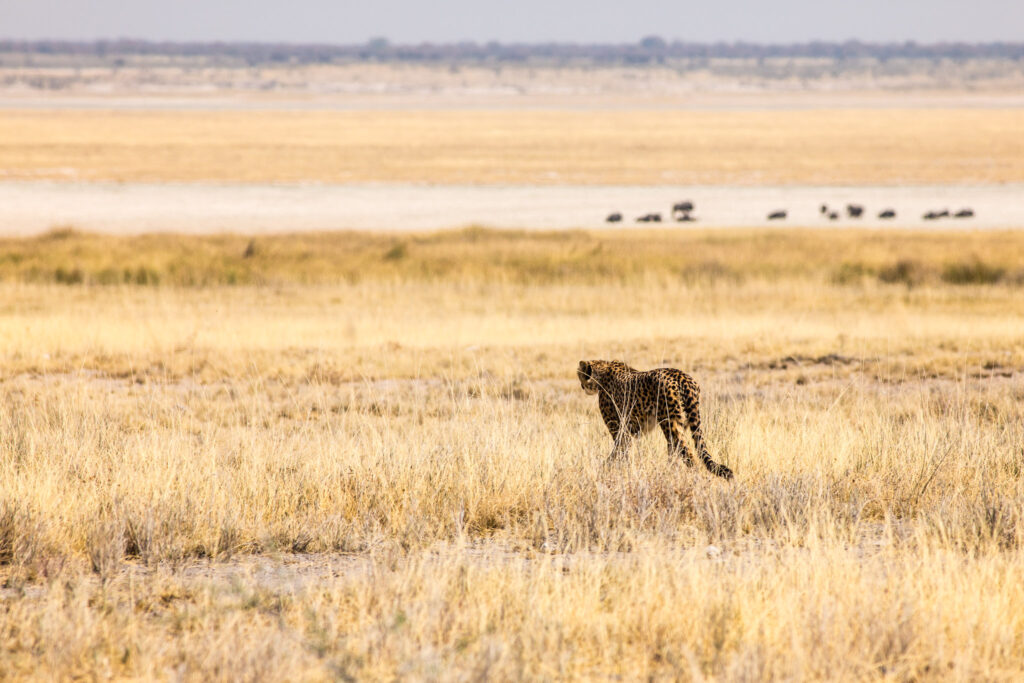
[0,57,1024,681]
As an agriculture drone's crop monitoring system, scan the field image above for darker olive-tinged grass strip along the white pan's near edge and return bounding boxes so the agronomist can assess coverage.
[6,227,1024,287]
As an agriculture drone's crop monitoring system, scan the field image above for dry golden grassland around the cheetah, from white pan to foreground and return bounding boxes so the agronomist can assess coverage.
[0,228,1024,681]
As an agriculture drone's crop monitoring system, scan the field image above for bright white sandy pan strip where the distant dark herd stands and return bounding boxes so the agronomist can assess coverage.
[0,181,1024,237]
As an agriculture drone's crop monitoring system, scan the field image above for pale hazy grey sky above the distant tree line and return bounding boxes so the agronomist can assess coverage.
[0,0,1024,44]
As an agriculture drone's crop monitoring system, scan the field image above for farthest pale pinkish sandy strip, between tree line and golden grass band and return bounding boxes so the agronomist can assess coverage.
[6,60,1024,109]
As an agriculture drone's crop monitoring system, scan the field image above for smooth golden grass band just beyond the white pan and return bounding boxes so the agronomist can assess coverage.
[6,109,1024,184]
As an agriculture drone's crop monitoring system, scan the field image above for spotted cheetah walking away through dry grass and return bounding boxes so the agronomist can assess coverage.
[577,360,732,479]
